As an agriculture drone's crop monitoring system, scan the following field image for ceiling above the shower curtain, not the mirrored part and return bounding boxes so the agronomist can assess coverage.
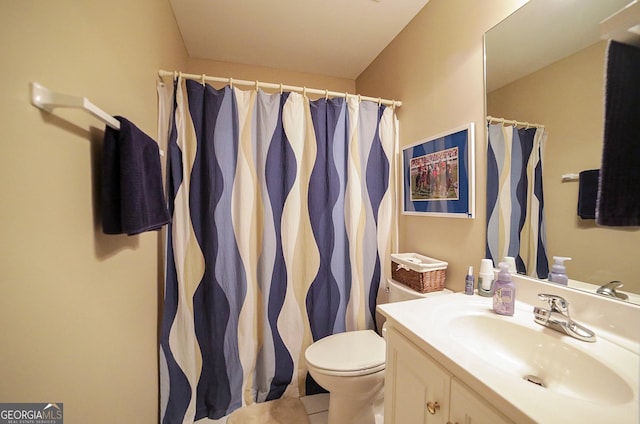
[169,0,429,79]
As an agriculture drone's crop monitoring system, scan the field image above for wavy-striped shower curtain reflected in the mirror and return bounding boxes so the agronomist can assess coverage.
[486,124,549,278]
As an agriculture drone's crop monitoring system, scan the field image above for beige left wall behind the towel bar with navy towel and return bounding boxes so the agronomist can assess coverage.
[0,0,187,424]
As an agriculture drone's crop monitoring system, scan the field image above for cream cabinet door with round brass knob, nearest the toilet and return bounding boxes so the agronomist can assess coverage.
[384,328,451,424]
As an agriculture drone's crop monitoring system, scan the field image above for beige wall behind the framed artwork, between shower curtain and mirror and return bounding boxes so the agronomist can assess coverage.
[356,0,524,290]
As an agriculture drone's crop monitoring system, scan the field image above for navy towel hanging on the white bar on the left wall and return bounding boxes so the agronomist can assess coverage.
[102,116,170,235]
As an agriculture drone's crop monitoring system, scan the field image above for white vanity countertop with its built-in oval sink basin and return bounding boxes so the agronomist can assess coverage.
[379,293,640,424]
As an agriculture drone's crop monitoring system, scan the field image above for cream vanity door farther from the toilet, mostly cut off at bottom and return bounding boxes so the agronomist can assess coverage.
[450,378,512,424]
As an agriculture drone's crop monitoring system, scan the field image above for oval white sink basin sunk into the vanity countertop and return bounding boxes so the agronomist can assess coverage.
[447,312,633,404]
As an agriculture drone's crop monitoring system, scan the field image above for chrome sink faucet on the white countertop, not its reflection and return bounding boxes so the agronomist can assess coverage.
[533,293,596,342]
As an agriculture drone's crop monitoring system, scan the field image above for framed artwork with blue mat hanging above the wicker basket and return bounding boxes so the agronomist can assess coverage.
[402,122,475,218]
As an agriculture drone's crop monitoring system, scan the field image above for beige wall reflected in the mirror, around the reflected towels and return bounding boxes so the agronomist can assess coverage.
[487,41,640,292]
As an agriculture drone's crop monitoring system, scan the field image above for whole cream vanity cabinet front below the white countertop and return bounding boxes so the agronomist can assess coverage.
[384,328,512,424]
